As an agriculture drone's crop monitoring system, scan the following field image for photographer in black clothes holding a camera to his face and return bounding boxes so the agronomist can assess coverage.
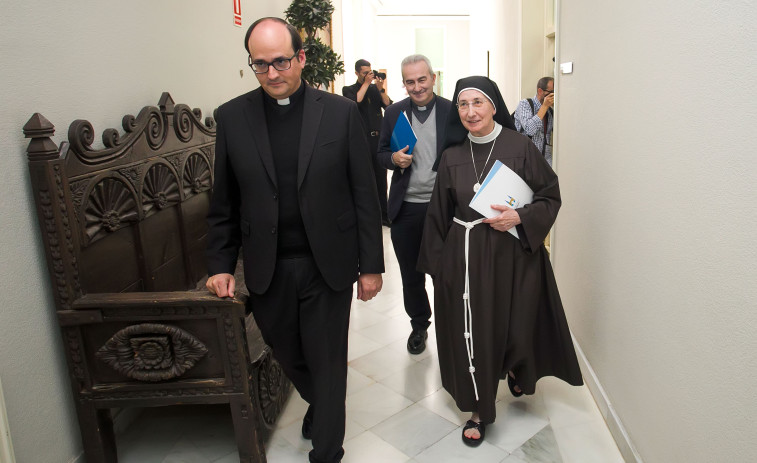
[342,59,392,226]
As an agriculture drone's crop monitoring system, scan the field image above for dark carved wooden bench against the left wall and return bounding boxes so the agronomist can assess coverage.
[24,93,291,463]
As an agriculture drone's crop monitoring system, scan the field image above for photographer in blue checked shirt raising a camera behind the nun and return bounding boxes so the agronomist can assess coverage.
[514,77,555,167]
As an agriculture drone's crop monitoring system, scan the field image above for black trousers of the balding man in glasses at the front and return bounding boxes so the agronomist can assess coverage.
[248,257,352,463]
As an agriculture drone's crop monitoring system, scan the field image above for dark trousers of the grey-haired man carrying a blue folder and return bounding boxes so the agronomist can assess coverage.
[391,201,431,330]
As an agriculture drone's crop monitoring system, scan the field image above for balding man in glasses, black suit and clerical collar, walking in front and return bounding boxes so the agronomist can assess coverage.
[206,18,384,462]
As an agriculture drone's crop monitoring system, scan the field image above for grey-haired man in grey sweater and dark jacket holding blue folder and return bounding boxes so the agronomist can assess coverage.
[378,55,452,354]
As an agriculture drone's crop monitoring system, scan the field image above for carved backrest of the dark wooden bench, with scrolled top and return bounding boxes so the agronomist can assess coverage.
[25,93,215,310]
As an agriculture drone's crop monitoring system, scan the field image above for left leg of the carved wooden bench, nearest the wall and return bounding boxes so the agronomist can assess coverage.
[76,400,118,463]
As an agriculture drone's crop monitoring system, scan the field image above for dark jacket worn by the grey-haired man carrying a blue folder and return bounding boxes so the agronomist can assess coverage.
[376,95,452,220]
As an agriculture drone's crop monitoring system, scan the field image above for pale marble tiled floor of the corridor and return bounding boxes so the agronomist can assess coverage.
[118,228,623,463]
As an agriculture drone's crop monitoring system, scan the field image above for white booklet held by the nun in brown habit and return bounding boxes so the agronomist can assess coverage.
[469,161,534,239]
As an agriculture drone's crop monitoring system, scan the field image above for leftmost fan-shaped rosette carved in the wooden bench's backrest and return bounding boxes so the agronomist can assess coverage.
[84,177,139,243]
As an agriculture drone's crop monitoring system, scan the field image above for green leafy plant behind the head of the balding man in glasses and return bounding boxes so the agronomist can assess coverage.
[285,0,344,87]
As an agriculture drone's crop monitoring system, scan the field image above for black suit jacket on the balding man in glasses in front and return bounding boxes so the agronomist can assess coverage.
[206,83,384,294]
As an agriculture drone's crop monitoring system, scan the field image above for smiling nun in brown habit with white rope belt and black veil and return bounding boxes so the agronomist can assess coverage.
[418,76,583,446]
